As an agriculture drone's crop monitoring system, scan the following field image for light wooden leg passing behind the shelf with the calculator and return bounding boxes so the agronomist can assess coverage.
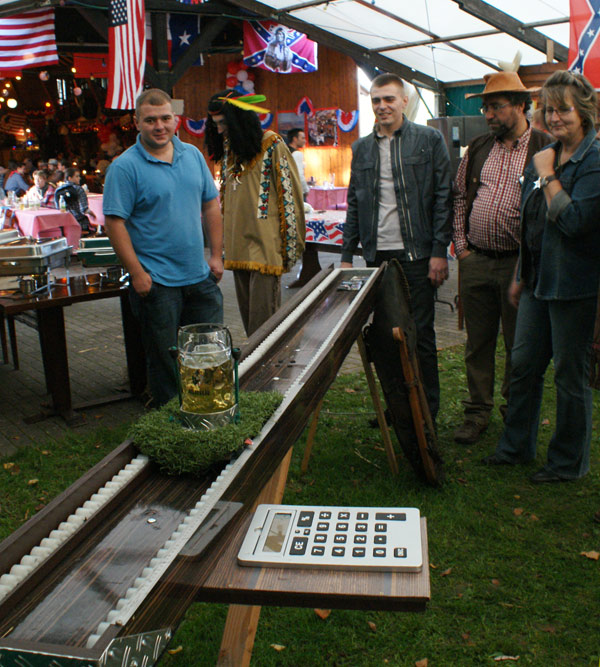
[217,448,294,667]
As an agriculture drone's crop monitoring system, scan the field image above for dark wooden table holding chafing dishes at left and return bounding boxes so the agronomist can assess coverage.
[0,275,146,424]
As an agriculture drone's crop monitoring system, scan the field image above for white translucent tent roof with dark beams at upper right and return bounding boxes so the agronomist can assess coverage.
[231,0,569,88]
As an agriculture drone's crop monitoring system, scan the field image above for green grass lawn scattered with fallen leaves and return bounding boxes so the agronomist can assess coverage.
[0,348,600,667]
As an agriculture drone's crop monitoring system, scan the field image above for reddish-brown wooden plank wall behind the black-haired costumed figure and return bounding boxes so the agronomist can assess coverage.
[173,46,358,185]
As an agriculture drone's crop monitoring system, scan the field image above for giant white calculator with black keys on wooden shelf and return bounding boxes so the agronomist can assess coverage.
[238,505,423,572]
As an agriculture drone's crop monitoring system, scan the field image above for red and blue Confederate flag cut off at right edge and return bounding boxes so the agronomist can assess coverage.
[569,0,600,88]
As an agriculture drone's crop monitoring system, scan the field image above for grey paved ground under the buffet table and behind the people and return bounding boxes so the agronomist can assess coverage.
[0,253,465,456]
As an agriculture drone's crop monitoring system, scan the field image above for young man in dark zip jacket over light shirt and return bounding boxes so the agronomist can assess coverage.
[341,74,452,420]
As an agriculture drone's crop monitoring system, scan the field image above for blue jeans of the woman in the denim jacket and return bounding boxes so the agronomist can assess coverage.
[496,288,596,479]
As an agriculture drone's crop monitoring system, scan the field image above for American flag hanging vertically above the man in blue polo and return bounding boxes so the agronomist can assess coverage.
[106,0,146,109]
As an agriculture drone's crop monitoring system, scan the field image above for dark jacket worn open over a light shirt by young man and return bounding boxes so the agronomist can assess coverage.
[342,117,452,262]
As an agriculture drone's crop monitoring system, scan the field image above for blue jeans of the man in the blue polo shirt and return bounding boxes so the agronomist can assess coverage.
[129,273,223,407]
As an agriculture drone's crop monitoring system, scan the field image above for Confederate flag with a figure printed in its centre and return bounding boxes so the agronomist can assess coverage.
[244,21,317,74]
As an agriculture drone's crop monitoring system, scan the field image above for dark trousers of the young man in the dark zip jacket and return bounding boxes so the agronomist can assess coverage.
[367,250,440,419]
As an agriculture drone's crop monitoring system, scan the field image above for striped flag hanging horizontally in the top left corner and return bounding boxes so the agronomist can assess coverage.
[0,9,58,69]
